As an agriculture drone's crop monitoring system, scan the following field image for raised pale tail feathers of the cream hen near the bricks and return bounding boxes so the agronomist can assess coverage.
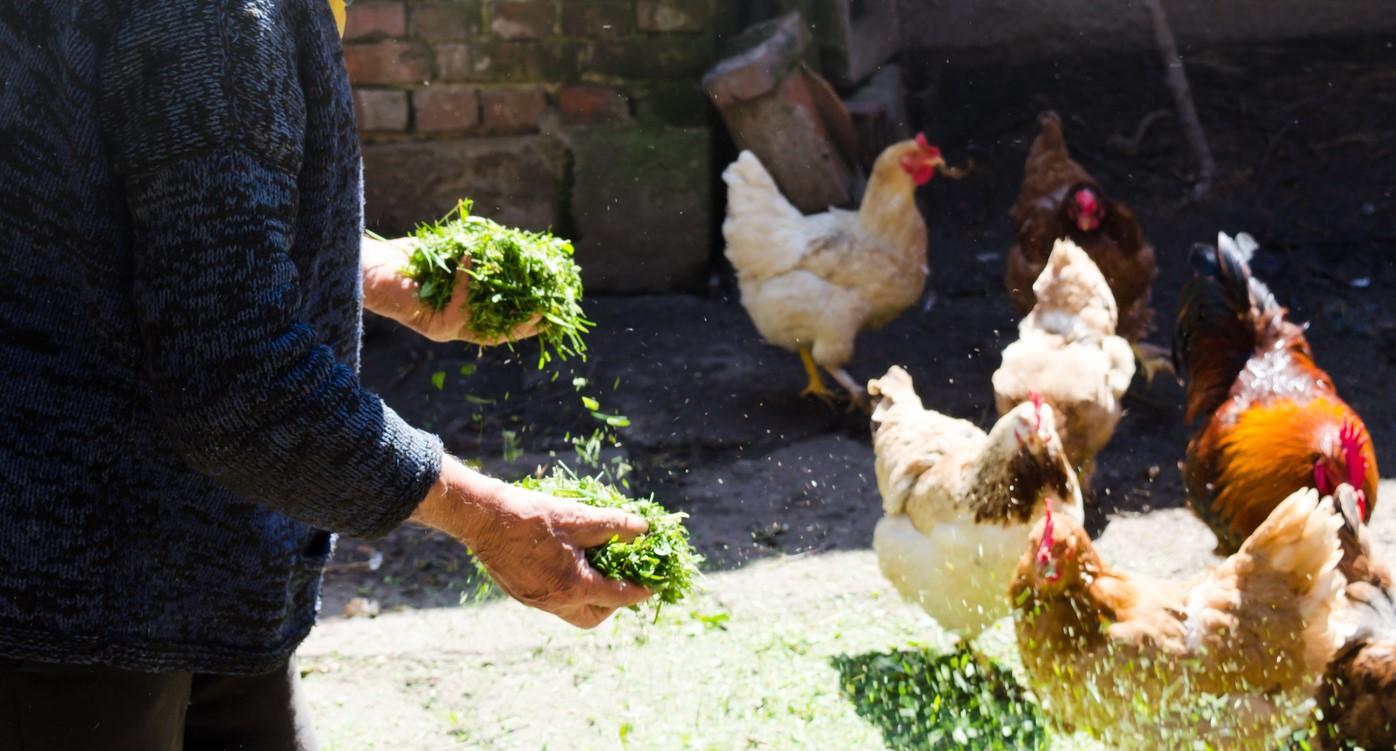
[722,151,804,278]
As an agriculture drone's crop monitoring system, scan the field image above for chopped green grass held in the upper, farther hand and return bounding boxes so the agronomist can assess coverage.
[405,200,592,367]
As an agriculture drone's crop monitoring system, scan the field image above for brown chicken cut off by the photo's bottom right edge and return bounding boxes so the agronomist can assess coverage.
[1316,483,1396,751]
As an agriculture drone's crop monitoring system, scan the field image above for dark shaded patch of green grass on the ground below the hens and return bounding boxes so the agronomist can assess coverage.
[833,642,1048,751]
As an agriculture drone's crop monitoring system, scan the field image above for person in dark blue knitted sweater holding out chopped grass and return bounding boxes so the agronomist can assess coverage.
[0,0,649,751]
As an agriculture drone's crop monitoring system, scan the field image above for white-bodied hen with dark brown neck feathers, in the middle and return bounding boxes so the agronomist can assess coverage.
[868,367,1082,641]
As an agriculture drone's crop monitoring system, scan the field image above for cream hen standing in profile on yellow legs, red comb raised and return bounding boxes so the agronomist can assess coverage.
[722,135,958,403]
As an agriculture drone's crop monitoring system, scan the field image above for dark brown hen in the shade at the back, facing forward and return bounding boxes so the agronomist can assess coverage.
[1004,112,1171,378]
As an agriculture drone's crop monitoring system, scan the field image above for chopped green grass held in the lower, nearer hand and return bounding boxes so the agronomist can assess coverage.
[517,468,702,618]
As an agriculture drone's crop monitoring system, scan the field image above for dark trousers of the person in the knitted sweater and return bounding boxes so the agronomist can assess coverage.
[0,650,317,751]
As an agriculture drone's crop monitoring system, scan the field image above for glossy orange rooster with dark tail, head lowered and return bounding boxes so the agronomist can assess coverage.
[1173,233,1379,553]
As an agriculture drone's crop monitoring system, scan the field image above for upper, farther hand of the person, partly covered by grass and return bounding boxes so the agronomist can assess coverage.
[360,231,537,346]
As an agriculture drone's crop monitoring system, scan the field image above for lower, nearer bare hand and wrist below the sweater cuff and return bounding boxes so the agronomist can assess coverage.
[412,458,651,628]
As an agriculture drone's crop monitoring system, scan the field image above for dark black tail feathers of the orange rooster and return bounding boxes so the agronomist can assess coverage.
[1173,233,1275,422]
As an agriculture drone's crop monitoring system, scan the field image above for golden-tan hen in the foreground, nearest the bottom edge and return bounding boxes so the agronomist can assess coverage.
[1011,490,1343,751]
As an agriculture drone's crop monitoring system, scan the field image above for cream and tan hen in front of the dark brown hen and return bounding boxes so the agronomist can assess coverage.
[993,240,1135,489]
